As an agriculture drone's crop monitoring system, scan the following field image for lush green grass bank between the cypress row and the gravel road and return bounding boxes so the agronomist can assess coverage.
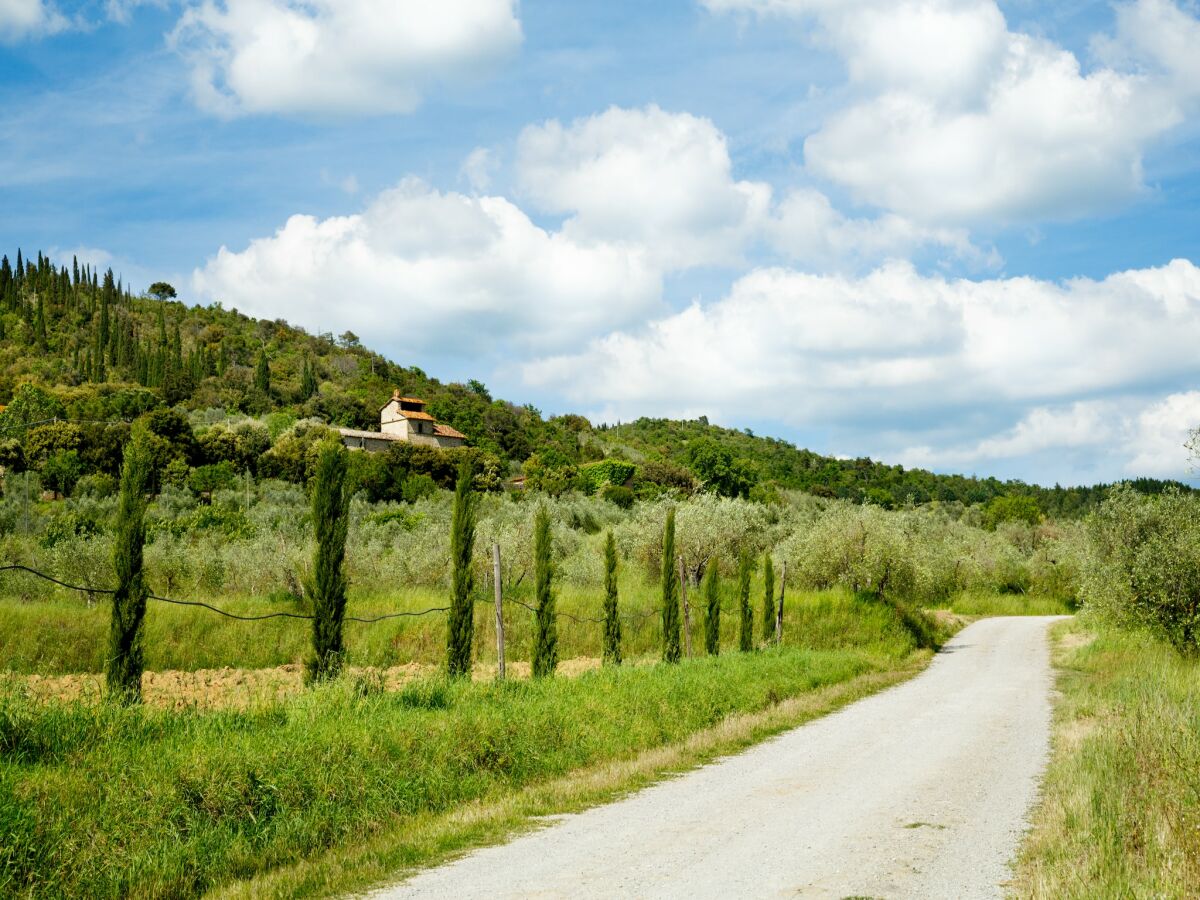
[0,607,928,896]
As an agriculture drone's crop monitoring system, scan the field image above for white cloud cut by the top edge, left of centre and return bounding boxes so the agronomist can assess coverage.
[170,0,521,115]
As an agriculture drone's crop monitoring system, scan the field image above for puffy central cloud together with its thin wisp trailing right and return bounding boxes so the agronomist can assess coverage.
[511,106,997,271]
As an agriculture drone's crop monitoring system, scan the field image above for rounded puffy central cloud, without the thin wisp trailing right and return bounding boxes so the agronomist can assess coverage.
[516,106,770,268]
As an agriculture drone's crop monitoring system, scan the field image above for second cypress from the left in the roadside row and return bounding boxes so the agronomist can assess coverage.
[306,444,350,683]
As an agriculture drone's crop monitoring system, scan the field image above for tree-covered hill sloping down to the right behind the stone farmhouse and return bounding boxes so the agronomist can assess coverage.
[0,244,1182,515]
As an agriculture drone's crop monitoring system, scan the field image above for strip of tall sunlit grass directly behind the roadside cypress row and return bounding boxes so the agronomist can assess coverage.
[0,578,926,674]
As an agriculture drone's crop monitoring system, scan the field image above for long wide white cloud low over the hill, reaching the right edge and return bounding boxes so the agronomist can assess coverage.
[524,260,1200,475]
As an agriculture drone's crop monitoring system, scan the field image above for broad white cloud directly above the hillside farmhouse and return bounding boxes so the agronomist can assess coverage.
[192,179,661,361]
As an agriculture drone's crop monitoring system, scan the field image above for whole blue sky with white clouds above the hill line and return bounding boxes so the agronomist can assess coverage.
[0,0,1200,485]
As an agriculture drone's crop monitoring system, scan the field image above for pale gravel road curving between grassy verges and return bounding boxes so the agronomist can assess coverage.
[376,618,1052,900]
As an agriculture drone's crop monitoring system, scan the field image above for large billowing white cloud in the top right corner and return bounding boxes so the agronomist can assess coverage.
[704,0,1198,224]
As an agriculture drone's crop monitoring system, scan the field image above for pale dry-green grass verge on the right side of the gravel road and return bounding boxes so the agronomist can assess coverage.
[1014,623,1200,899]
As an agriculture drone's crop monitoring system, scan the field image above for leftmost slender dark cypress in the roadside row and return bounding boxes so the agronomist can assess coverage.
[106,438,150,703]
